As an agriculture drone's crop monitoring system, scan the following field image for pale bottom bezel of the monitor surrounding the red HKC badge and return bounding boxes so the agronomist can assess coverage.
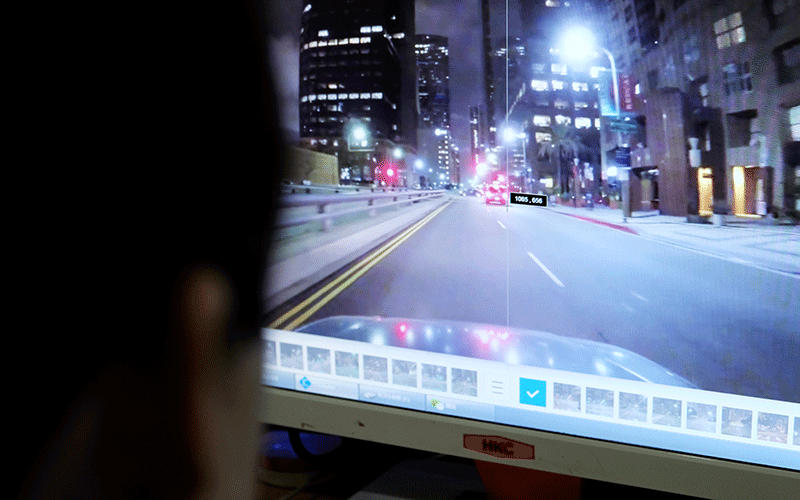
[258,385,800,500]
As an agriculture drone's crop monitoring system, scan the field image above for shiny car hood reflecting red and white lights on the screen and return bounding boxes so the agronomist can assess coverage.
[297,316,696,388]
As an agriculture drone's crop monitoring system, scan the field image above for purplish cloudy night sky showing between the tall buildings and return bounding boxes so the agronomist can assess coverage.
[267,0,519,172]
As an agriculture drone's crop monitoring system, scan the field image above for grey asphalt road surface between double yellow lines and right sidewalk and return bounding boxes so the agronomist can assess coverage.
[276,194,800,402]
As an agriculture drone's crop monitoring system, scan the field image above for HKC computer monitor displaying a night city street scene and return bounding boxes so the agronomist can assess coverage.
[259,0,800,498]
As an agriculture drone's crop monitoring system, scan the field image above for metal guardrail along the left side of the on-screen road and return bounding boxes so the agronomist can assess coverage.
[276,188,445,231]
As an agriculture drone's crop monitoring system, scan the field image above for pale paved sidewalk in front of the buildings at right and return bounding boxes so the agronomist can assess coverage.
[547,205,800,278]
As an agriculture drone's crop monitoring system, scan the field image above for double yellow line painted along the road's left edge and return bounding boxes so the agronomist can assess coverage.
[268,201,450,330]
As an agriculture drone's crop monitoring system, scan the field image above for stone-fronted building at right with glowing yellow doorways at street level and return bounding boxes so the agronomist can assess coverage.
[607,0,800,222]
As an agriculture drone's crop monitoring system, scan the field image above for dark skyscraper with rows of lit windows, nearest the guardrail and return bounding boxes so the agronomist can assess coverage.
[300,0,417,182]
